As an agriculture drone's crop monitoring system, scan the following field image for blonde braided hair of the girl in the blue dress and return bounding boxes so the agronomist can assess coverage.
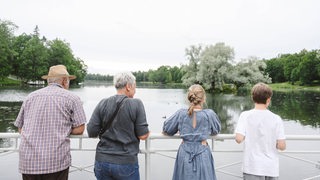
[187,84,206,115]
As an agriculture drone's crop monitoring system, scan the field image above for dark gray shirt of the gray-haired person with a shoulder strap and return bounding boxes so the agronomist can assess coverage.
[87,95,149,164]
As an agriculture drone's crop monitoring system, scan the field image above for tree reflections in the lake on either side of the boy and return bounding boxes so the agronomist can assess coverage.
[207,91,320,133]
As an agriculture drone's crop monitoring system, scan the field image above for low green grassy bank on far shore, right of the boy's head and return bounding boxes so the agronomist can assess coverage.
[269,82,320,92]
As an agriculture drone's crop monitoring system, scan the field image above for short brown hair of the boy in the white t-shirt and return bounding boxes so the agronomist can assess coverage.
[251,83,272,104]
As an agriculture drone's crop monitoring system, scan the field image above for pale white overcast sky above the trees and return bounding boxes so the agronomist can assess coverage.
[0,0,320,74]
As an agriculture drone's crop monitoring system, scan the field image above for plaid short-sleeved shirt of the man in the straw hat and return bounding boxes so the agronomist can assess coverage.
[14,84,86,174]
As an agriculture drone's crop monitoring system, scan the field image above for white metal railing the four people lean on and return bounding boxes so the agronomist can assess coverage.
[0,133,320,180]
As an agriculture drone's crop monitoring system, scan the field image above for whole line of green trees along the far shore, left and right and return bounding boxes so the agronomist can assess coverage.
[0,20,320,91]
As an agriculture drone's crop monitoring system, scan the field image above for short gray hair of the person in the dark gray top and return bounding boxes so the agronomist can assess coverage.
[113,72,136,89]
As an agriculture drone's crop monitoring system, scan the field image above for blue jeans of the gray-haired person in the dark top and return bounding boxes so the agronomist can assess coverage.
[94,161,140,180]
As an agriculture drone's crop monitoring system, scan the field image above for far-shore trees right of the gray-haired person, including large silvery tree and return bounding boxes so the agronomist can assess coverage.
[84,43,320,91]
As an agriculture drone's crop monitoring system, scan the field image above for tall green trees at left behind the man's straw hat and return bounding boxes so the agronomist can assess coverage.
[0,19,87,83]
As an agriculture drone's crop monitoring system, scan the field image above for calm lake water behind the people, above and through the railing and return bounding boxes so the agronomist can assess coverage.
[0,82,320,180]
